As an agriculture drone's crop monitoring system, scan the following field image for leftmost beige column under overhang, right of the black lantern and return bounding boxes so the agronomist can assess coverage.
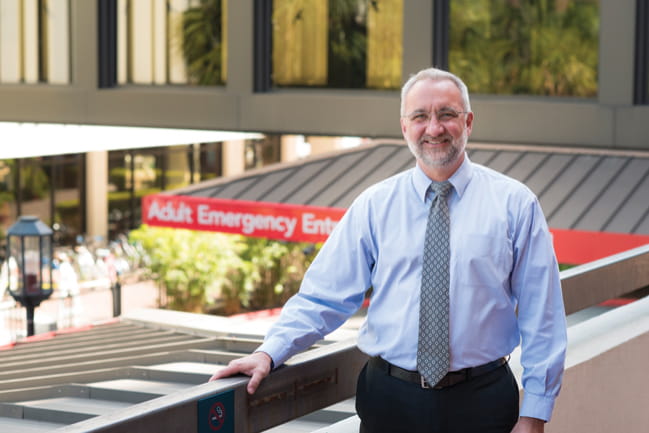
[86,151,108,239]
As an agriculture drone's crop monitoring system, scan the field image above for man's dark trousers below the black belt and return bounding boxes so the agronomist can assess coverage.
[356,365,519,433]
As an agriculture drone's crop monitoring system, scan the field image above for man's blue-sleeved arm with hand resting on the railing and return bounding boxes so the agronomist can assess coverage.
[210,194,371,394]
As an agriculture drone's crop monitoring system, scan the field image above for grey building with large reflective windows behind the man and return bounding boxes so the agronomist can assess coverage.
[0,0,649,242]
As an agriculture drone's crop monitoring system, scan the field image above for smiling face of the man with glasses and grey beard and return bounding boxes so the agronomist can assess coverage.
[401,79,473,172]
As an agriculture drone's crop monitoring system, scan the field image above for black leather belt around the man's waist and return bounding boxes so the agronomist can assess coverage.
[369,356,507,389]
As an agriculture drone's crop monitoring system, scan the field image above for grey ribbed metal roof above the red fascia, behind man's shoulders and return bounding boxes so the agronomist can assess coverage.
[168,142,649,235]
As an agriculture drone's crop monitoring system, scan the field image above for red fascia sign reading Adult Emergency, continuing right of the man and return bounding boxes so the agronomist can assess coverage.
[142,194,649,265]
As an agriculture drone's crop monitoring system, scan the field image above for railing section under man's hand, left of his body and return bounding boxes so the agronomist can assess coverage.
[55,339,367,433]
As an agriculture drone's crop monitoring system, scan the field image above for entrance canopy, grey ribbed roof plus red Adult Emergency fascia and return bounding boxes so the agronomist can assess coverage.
[143,143,649,264]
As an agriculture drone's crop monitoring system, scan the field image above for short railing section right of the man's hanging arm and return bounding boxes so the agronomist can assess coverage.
[561,244,649,314]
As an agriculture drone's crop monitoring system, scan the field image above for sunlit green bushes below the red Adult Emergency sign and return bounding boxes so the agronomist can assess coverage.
[129,226,316,314]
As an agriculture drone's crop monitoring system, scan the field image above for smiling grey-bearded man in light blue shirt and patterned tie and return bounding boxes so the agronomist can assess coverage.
[211,68,566,433]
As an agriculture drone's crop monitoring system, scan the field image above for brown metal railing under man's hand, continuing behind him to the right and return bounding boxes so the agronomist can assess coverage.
[49,245,649,433]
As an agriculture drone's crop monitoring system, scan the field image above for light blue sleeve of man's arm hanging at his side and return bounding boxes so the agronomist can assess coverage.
[511,200,567,421]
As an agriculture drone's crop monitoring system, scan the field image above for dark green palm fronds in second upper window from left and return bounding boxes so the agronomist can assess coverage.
[182,0,223,86]
